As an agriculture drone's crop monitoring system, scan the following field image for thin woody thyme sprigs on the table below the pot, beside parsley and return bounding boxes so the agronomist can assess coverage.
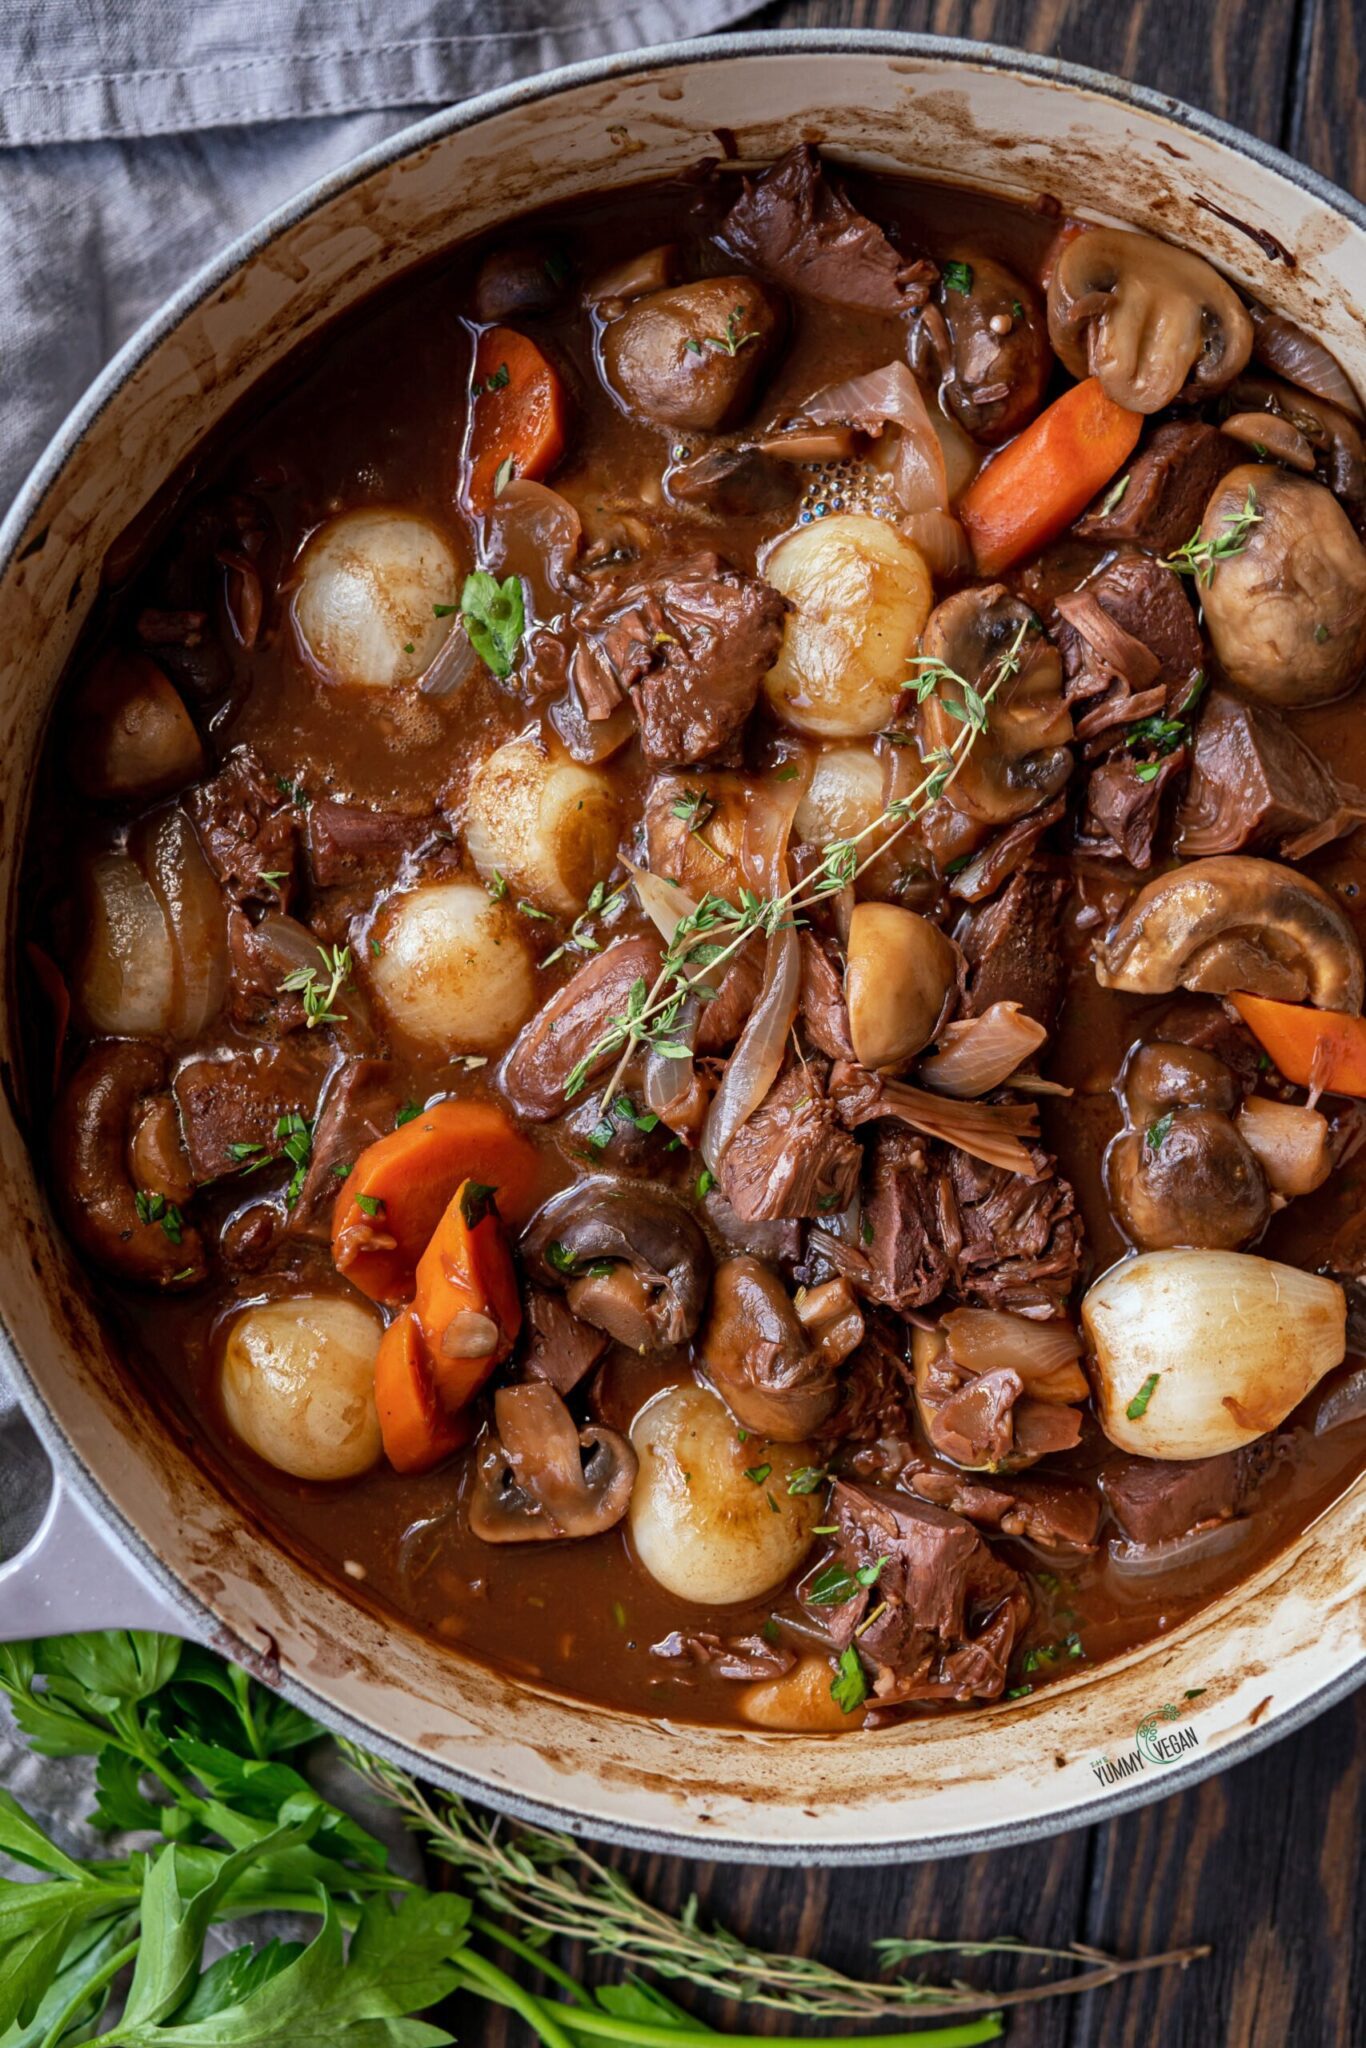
[342,1743,1204,2023]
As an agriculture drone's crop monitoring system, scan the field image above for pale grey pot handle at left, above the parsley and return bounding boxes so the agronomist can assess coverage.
[0,1473,193,1642]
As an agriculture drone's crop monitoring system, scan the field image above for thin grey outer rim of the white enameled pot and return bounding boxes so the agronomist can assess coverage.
[0,29,1366,1868]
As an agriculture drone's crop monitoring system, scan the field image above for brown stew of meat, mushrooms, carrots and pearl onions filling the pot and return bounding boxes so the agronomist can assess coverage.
[18,147,1366,1731]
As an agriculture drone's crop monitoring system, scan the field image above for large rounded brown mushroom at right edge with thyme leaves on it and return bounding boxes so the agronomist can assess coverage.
[1200,463,1366,707]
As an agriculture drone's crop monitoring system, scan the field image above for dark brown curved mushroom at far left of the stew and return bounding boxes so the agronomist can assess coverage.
[51,1040,205,1288]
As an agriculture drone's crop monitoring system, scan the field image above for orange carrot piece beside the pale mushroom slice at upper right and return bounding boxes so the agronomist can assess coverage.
[956,377,1143,575]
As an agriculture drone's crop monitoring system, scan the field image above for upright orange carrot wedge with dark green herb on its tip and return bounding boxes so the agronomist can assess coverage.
[412,1180,522,1415]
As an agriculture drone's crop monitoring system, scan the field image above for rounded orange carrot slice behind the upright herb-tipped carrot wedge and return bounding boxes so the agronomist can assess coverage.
[332,1102,549,1303]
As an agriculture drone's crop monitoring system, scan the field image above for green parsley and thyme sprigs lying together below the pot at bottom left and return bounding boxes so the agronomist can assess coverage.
[0,1630,1202,2048]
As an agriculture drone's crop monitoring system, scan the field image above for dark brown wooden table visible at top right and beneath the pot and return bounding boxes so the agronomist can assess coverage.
[459,0,1366,2048]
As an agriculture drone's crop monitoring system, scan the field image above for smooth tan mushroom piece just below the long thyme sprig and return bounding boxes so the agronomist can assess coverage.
[844,903,961,1069]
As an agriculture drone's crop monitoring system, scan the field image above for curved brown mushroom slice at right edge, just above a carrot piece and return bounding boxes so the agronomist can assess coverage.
[1096,854,1362,1014]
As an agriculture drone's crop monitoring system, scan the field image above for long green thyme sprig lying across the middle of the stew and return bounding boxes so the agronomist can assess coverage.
[565,614,1040,1100]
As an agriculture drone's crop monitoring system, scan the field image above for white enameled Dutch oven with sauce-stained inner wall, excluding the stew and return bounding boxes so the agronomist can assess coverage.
[0,33,1366,1862]
